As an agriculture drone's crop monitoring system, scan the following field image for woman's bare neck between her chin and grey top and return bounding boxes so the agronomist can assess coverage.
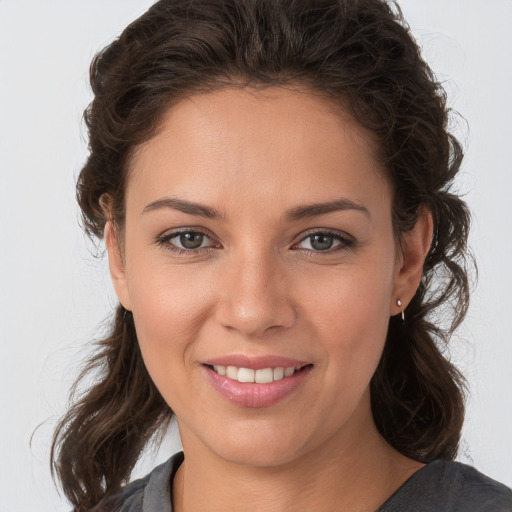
[173,400,423,512]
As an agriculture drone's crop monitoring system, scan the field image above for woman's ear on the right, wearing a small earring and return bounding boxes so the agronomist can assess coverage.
[390,209,434,315]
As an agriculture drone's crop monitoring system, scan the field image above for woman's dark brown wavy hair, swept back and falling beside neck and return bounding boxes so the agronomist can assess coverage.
[52,0,469,511]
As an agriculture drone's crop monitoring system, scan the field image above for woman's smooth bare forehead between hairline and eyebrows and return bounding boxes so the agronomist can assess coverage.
[127,87,389,215]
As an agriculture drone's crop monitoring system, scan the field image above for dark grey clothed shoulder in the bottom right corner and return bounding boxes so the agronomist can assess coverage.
[379,460,512,512]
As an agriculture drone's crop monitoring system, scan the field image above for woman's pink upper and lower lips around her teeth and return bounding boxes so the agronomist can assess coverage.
[203,357,313,408]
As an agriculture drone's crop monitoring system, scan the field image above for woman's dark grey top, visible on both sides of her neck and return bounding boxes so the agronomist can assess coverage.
[104,452,512,512]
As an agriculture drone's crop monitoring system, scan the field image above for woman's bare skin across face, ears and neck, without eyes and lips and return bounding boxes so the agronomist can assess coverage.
[106,88,432,512]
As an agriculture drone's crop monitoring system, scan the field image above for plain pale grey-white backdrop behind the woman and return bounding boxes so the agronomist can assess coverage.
[0,0,512,512]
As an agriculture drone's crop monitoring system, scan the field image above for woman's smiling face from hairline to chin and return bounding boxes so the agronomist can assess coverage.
[108,88,424,466]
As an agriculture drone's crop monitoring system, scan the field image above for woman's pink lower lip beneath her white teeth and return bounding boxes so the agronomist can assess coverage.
[204,366,312,407]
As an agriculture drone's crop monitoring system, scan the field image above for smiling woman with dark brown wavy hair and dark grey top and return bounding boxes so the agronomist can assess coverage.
[54,0,512,512]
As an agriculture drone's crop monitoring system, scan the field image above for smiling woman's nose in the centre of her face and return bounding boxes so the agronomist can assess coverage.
[216,249,298,339]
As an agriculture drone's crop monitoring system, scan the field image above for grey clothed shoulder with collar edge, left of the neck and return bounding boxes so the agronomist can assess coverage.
[98,452,183,512]
